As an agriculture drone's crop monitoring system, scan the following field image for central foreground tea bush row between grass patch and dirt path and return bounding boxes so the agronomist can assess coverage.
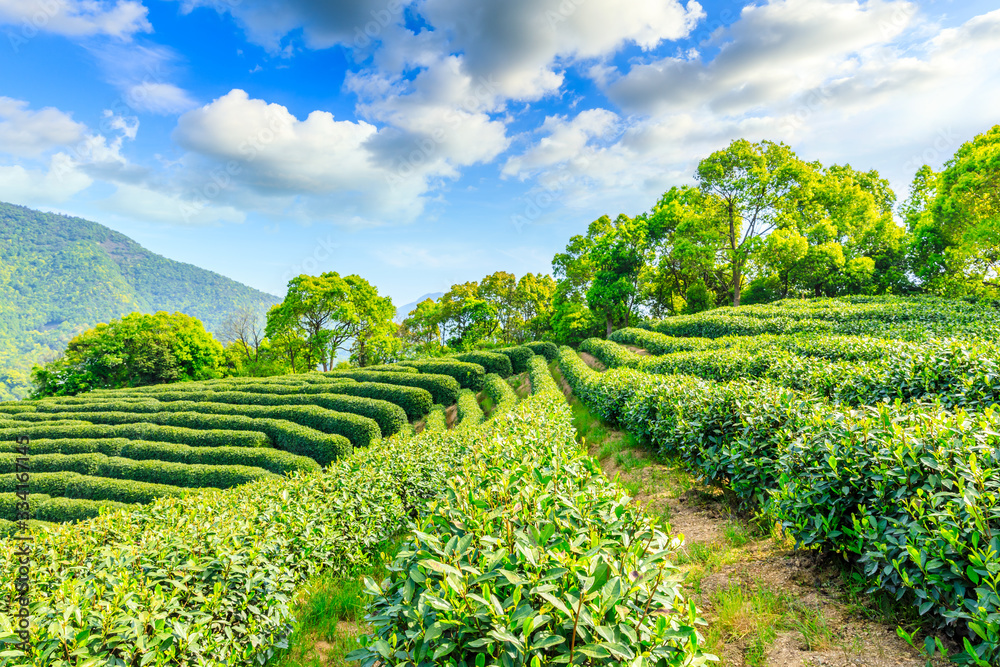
[348,362,714,667]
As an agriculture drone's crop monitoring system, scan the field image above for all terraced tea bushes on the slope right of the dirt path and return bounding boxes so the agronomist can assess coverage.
[559,298,1000,665]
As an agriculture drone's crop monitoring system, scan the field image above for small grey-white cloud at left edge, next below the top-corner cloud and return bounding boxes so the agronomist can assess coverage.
[0,97,87,157]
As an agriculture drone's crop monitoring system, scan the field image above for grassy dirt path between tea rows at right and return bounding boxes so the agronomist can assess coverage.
[554,360,950,667]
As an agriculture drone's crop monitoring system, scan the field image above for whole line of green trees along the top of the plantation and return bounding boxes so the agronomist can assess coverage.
[25,125,1000,396]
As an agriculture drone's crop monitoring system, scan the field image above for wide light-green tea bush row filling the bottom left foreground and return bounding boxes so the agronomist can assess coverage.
[0,370,568,667]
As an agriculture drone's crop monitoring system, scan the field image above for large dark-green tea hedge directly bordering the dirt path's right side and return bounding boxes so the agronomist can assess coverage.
[560,348,1000,664]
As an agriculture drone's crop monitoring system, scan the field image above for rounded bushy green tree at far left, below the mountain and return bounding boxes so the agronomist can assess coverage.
[32,311,224,398]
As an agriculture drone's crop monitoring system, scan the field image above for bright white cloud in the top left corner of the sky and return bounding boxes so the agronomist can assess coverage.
[0,0,153,40]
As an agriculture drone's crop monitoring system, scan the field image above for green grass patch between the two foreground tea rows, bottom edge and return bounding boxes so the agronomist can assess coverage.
[267,540,401,667]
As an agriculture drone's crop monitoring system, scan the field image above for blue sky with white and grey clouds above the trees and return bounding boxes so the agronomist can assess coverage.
[0,0,1000,305]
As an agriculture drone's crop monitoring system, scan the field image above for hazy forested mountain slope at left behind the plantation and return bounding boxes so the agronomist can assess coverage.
[0,202,281,400]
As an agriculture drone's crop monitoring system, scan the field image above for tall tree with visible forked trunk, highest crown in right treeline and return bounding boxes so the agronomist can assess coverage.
[698,139,810,306]
